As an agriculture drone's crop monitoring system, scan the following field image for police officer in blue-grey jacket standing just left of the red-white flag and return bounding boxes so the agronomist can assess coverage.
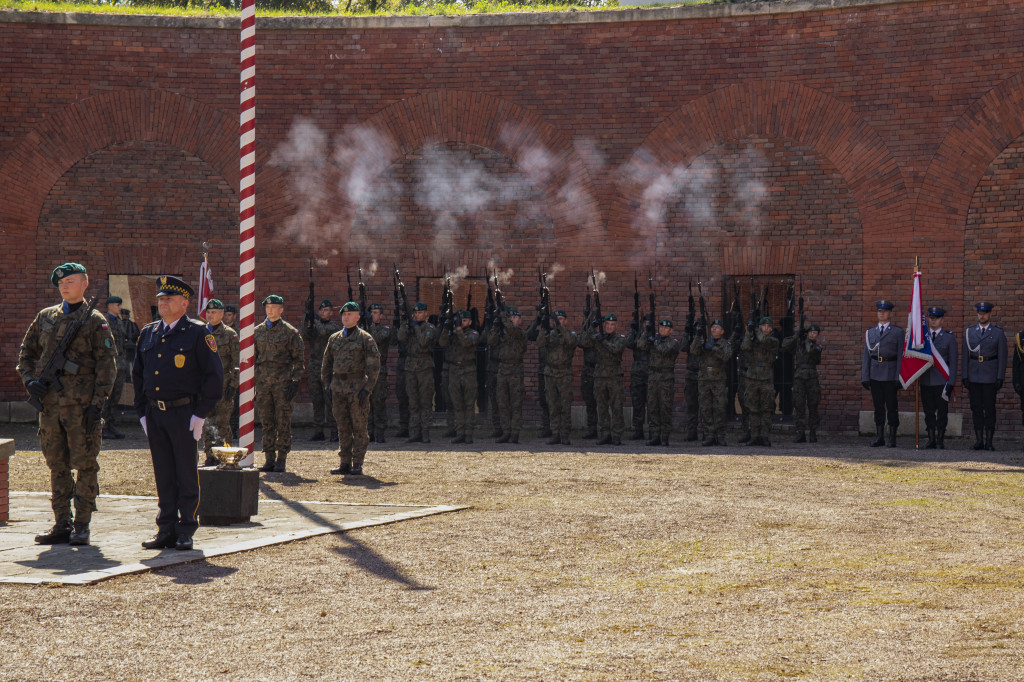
[860,299,903,447]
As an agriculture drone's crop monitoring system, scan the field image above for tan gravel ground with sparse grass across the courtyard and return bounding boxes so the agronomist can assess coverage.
[0,427,1024,680]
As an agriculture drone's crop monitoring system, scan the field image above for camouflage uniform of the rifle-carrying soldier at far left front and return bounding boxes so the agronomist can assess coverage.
[17,302,117,524]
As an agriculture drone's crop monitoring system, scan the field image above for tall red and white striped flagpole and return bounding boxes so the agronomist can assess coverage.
[239,0,256,466]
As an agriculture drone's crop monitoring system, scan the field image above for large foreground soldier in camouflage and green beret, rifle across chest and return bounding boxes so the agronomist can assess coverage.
[16,263,117,545]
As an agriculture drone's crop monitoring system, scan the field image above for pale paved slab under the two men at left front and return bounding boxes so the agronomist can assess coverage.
[0,493,467,585]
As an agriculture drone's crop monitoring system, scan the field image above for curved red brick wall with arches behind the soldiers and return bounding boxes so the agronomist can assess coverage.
[0,0,1024,430]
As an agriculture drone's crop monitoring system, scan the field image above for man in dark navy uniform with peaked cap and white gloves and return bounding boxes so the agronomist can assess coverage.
[132,276,224,550]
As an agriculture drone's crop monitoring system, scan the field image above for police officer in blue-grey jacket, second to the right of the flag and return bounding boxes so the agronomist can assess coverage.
[963,301,1007,450]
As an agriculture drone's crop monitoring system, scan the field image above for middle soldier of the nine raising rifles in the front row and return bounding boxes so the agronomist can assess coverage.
[580,313,626,445]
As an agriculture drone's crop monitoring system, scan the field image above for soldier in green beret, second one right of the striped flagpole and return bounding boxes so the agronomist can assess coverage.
[321,301,381,476]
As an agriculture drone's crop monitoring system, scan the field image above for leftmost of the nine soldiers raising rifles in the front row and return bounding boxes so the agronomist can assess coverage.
[398,301,437,442]
